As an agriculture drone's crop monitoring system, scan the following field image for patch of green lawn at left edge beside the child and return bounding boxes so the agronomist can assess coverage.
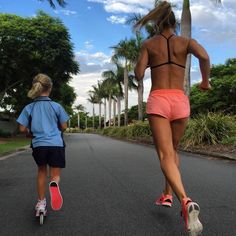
[0,139,30,156]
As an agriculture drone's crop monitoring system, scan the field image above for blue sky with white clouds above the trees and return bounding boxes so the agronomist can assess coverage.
[0,0,236,113]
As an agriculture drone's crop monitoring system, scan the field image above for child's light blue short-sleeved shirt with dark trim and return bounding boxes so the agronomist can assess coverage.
[17,97,69,148]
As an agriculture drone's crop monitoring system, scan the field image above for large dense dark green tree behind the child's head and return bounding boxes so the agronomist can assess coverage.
[0,12,79,112]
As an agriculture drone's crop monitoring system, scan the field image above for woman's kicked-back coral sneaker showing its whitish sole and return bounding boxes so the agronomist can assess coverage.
[182,198,203,236]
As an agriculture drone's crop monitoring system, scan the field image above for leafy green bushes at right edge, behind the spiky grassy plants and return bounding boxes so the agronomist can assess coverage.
[190,58,236,116]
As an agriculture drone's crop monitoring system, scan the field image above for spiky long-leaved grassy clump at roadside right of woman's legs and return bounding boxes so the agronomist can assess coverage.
[182,113,236,148]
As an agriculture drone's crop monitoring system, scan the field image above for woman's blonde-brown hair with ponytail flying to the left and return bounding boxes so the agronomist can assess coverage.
[134,1,176,33]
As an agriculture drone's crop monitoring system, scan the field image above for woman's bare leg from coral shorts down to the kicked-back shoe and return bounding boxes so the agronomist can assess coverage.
[149,115,186,201]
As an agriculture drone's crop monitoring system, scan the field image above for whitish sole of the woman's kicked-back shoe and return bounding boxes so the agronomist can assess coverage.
[187,202,203,236]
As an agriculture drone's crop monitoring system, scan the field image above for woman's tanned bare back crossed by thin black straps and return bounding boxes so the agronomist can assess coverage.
[144,35,189,90]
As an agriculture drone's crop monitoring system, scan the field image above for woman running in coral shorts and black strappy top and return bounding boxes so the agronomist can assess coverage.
[135,1,210,235]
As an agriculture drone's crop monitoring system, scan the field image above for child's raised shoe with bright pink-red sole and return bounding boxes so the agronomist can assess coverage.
[49,181,63,211]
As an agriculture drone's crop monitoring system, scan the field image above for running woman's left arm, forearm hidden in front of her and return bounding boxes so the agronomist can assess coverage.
[134,44,148,80]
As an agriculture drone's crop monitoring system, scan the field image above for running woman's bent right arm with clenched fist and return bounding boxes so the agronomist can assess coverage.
[188,39,211,90]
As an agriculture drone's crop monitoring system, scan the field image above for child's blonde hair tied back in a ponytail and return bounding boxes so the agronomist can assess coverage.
[28,74,52,99]
